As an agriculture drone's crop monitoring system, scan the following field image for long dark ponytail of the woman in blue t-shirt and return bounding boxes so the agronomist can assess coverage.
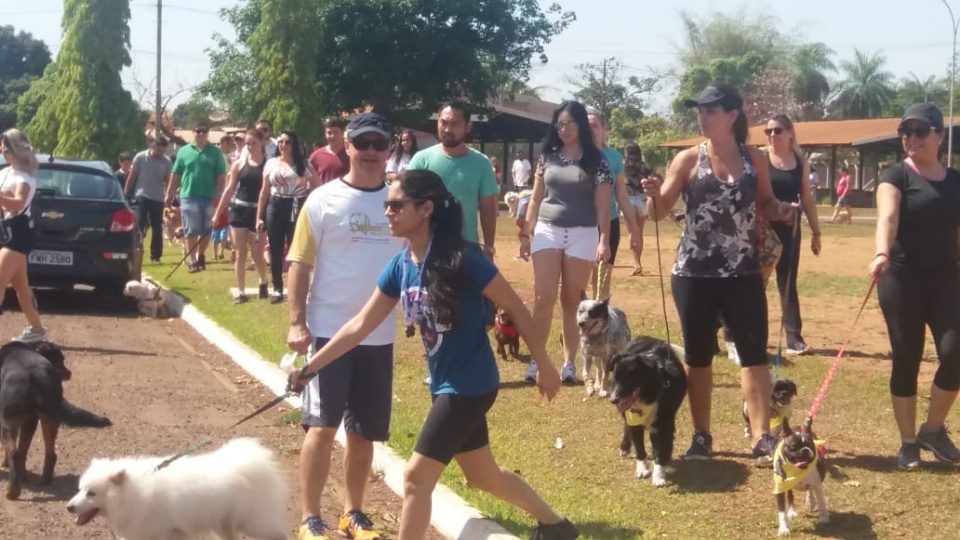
[400,169,467,327]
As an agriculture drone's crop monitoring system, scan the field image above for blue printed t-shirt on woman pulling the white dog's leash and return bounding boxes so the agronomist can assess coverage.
[377,249,500,396]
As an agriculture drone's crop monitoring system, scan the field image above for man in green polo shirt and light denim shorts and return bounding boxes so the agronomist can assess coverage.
[165,124,227,273]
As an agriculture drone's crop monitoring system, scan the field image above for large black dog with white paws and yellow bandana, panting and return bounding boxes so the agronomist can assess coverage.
[609,336,687,486]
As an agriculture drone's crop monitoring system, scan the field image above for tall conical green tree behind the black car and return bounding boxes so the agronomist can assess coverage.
[25,0,143,161]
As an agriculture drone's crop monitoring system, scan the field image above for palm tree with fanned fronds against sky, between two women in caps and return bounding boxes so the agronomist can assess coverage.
[832,49,896,118]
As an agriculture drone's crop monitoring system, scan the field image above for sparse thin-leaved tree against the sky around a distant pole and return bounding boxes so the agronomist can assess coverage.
[567,59,658,118]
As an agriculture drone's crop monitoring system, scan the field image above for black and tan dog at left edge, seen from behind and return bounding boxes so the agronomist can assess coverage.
[0,341,111,499]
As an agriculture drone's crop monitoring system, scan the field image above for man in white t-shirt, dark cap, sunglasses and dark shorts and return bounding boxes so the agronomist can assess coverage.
[287,113,403,540]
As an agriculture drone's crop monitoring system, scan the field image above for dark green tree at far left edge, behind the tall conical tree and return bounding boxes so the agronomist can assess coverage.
[0,26,50,132]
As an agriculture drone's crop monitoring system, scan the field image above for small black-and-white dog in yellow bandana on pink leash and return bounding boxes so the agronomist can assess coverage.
[773,418,830,536]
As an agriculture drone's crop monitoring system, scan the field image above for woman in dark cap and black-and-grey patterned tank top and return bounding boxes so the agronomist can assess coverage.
[643,85,795,462]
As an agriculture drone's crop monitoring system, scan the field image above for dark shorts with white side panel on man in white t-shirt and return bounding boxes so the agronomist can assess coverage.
[300,338,393,442]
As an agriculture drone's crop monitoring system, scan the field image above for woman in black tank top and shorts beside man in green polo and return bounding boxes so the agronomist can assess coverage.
[213,129,268,305]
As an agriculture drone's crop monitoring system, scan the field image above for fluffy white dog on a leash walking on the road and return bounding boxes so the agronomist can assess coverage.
[67,438,289,540]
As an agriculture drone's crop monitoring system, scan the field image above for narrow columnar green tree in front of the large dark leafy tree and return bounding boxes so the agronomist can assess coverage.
[250,0,320,140]
